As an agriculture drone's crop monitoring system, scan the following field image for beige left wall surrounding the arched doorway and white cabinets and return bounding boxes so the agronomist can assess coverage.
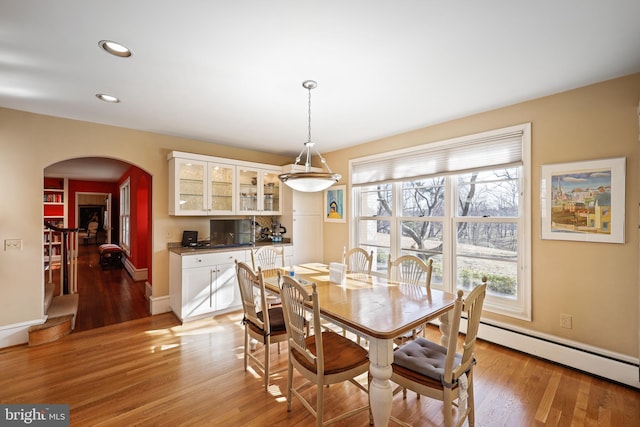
[0,108,291,328]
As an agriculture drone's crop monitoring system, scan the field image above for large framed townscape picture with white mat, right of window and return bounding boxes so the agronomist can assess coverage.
[540,157,625,243]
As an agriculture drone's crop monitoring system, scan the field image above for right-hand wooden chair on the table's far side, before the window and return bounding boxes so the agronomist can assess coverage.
[387,255,433,345]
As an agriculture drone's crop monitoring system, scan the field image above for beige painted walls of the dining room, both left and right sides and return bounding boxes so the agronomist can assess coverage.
[0,74,640,356]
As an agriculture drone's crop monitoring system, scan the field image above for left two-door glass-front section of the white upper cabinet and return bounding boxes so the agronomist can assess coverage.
[169,157,236,215]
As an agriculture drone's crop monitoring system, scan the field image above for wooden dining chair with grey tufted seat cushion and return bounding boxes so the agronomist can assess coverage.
[391,278,487,427]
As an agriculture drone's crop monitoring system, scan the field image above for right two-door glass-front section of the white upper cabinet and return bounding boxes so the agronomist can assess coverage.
[236,165,282,215]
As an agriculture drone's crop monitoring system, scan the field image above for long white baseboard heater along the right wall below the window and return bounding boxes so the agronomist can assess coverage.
[468,319,640,389]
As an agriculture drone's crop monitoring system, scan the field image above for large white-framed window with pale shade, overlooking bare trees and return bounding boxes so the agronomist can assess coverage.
[350,124,531,320]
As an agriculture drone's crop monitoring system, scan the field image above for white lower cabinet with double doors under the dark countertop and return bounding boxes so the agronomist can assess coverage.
[169,250,250,322]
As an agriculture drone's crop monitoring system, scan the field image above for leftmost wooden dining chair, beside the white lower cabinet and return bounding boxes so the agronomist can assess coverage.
[236,260,287,391]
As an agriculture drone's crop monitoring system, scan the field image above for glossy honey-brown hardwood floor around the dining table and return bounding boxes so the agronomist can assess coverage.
[0,304,640,427]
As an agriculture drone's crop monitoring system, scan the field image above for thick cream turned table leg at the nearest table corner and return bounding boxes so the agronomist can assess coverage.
[369,338,393,426]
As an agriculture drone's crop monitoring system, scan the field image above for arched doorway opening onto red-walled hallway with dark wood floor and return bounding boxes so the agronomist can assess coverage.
[43,157,152,331]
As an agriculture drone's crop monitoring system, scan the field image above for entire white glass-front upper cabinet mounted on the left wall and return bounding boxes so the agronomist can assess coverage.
[168,151,282,216]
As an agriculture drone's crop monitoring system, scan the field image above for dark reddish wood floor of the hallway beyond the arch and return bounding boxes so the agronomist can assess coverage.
[45,244,150,332]
